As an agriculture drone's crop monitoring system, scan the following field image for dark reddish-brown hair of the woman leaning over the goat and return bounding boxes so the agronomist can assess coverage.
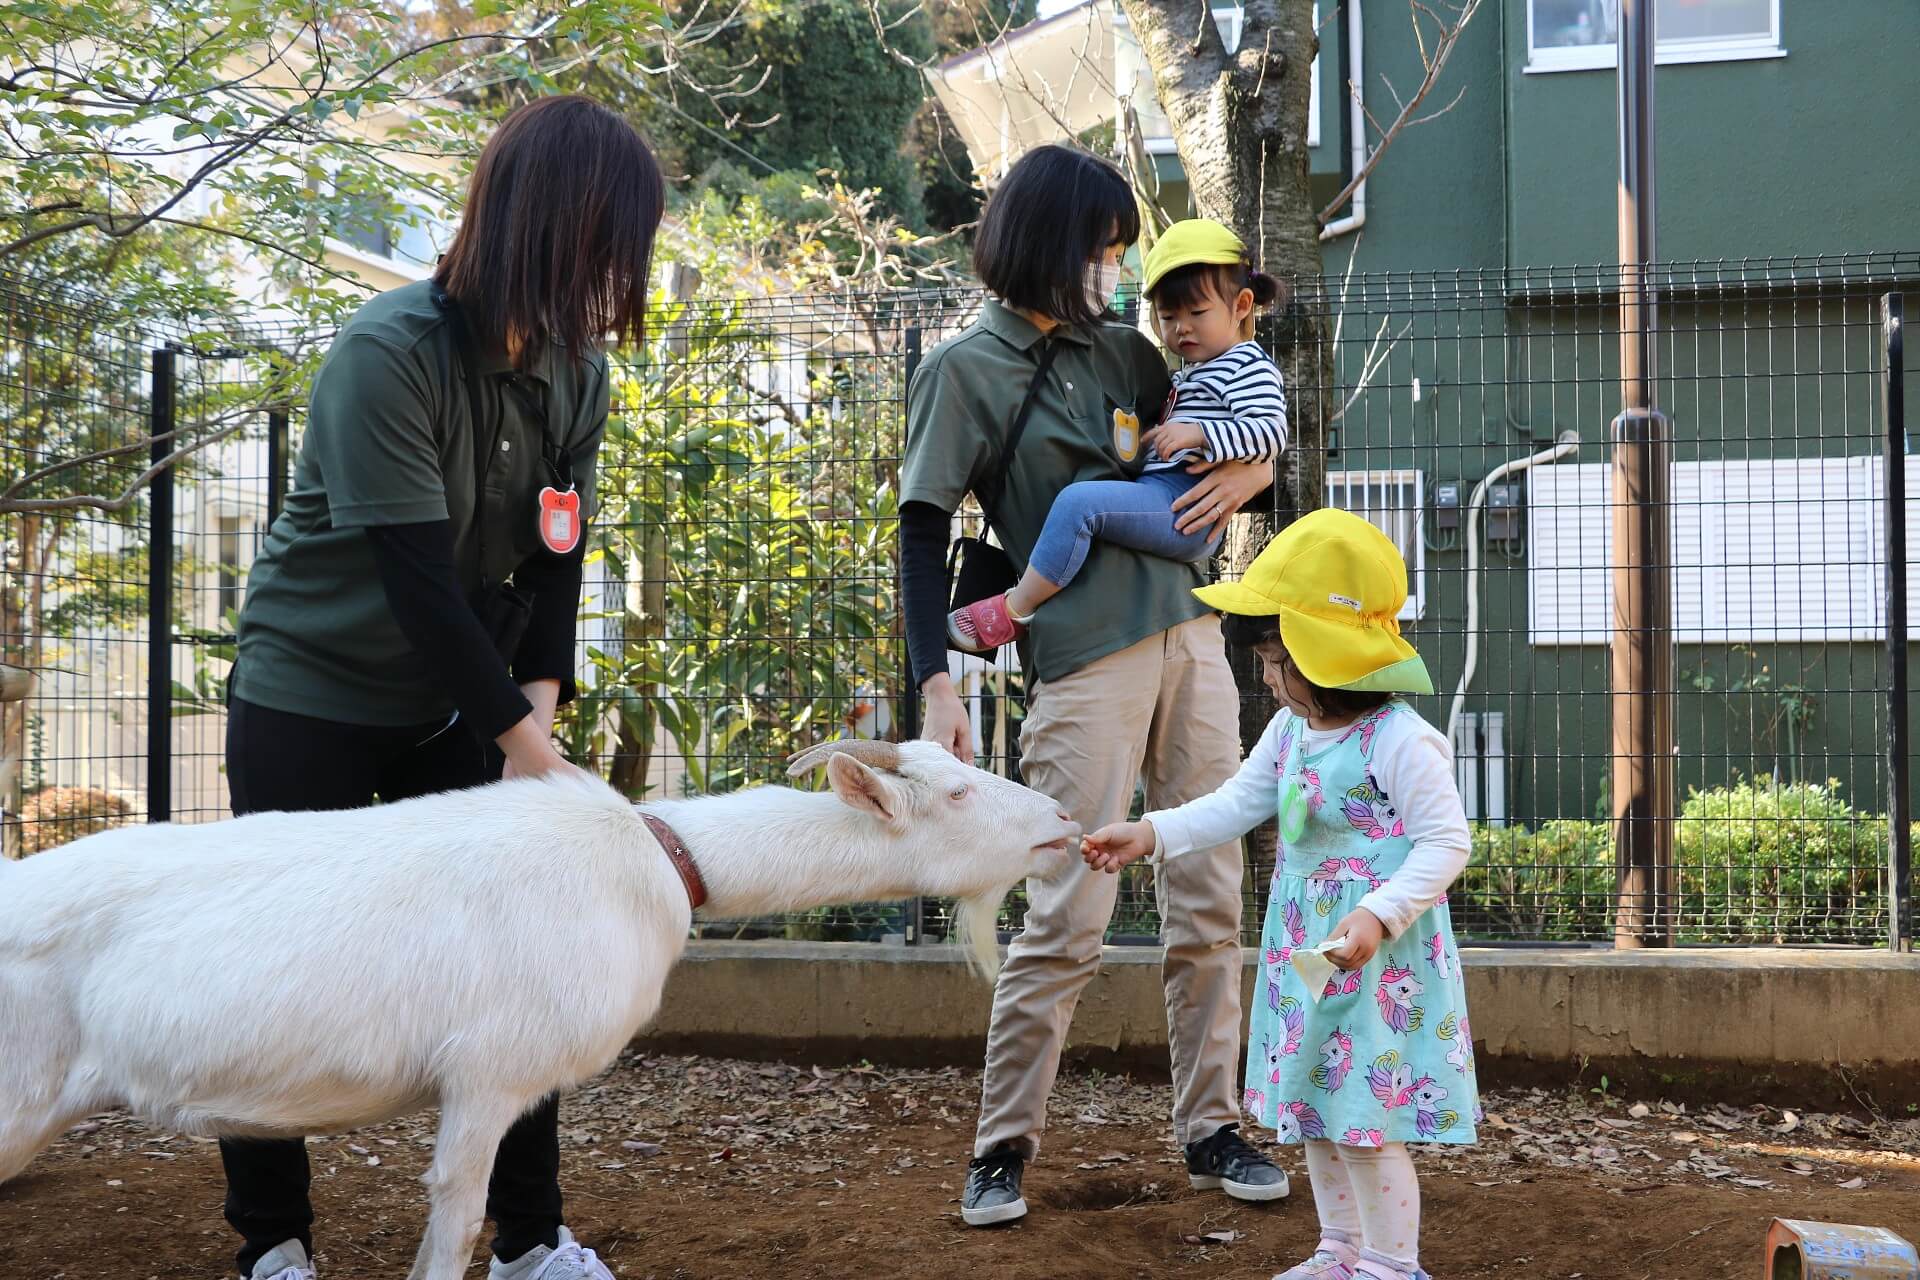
[434,94,666,368]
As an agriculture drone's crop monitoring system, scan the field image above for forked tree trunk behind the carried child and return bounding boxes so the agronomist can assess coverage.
[1121,0,1338,885]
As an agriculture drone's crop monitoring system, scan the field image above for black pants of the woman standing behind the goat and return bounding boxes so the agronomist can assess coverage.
[221,699,561,1276]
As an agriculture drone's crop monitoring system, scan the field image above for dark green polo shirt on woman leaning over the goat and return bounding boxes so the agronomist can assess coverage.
[232,280,609,725]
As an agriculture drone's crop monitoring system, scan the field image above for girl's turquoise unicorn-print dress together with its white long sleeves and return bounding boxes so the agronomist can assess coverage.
[1148,700,1480,1148]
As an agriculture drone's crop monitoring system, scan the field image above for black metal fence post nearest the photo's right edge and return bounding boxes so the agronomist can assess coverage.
[1880,294,1914,952]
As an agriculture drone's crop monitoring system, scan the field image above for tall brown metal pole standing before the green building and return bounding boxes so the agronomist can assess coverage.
[1611,0,1678,948]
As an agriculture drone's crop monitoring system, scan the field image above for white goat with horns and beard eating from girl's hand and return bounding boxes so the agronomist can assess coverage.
[0,741,1079,1280]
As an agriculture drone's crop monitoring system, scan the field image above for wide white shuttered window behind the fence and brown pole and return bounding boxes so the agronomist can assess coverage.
[1526,457,1920,645]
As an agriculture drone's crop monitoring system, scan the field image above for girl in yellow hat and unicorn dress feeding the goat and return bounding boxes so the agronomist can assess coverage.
[1083,510,1480,1280]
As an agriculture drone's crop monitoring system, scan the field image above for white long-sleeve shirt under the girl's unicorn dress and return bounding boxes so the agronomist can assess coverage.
[1146,710,1473,936]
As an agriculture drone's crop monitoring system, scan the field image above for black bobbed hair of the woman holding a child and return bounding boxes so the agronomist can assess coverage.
[973,146,1140,324]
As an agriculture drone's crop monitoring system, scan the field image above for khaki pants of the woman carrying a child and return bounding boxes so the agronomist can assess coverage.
[973,616,1240,1159]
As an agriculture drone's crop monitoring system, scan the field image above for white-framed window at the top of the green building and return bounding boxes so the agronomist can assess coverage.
[1526,0,1784,71]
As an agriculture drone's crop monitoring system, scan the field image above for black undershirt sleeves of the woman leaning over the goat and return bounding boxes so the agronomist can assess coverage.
[367,520,586,741]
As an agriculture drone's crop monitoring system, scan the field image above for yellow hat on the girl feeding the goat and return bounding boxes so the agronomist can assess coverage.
[1194,507,1434,693]
